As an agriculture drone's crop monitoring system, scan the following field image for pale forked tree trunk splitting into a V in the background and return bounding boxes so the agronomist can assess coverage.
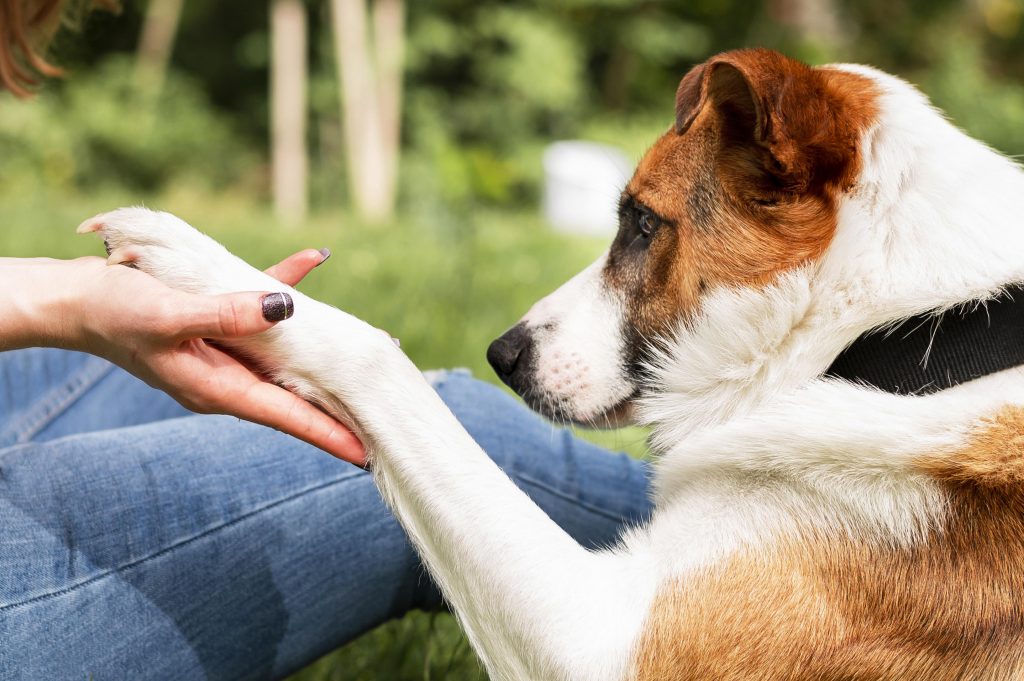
[331,0,406,220]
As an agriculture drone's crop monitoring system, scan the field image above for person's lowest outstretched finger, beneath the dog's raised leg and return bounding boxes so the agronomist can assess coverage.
[231,382,367,467]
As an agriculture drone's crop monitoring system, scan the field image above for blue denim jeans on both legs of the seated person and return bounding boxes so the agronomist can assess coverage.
[0,349,650,681]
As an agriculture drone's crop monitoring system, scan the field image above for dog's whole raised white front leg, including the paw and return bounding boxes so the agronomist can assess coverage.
[80,209,656,681]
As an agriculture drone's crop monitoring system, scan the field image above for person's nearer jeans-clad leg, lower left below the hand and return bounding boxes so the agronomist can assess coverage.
[0,416,393,680]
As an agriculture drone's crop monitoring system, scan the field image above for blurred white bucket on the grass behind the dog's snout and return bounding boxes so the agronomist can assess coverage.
[544,141,632,236]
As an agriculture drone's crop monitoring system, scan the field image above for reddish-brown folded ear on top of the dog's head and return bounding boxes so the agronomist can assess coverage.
[676,49,835,191]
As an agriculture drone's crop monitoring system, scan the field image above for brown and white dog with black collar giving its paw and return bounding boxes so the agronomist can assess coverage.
[80,49,1024,681]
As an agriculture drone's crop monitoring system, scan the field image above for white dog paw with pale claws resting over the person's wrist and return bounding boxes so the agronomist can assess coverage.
[78,208,262,293]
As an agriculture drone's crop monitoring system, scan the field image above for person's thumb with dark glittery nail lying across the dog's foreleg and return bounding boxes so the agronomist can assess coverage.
[181,292,295,338]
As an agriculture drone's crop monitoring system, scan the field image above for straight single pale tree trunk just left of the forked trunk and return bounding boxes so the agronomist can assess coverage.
[270,0,308,224]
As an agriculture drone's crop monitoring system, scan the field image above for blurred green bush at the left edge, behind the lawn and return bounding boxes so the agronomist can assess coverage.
[0,57,255,191]
